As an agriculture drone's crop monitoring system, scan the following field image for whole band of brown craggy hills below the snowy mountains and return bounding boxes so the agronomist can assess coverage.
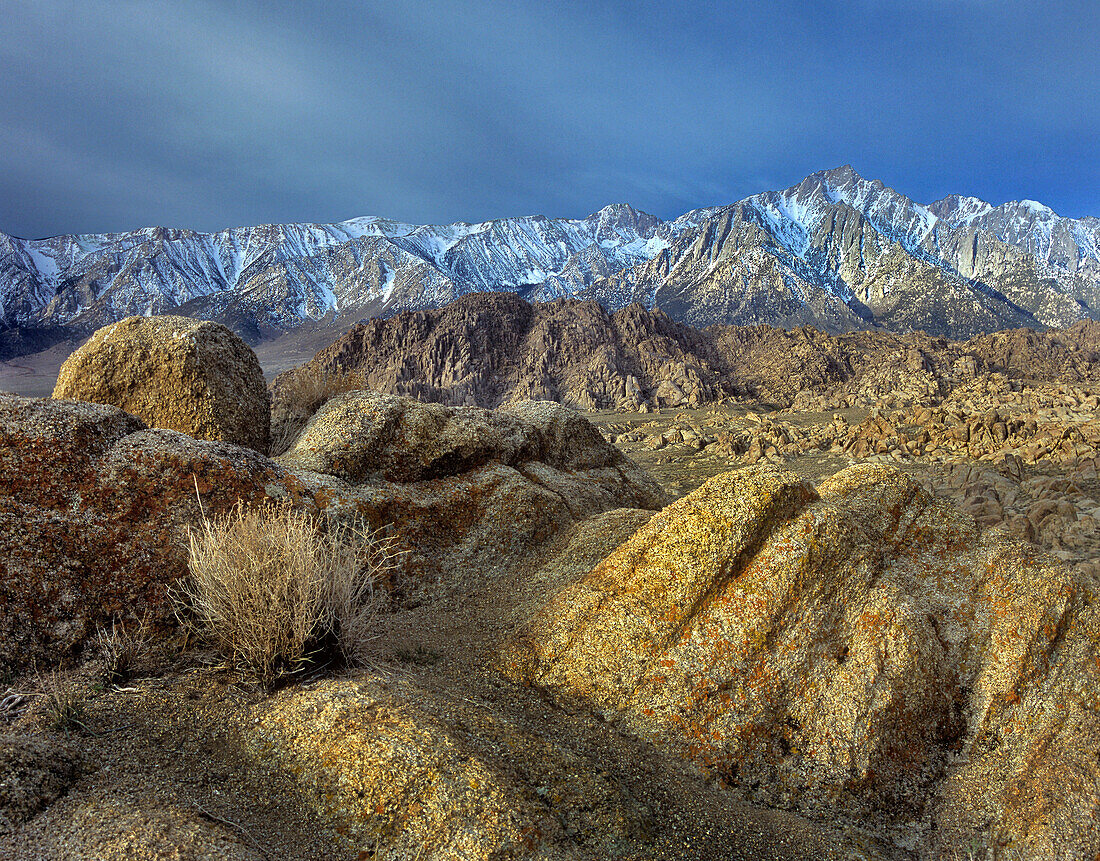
[274,294,1100,420]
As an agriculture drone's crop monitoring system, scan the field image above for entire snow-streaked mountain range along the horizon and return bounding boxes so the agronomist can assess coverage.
[0,166,1100,340]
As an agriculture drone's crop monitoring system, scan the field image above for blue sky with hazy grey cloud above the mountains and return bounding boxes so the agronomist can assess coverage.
[0,0,1100,236]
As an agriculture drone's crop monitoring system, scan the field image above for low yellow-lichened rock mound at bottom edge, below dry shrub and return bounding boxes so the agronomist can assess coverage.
[244,680,573,861]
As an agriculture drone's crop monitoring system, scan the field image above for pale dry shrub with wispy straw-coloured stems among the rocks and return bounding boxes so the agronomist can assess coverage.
[173,506,396,685]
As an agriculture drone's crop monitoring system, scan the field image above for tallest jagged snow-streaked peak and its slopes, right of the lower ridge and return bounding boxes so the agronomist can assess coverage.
[584,166,1100,338]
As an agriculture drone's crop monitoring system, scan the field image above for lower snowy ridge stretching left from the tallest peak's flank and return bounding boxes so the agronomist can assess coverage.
[0,205,705,328]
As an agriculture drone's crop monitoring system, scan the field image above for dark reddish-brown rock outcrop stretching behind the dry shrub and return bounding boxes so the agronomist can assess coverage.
[0,393,664,670]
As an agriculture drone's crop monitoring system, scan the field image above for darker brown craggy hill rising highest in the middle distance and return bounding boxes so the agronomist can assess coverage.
[274,294,733,420]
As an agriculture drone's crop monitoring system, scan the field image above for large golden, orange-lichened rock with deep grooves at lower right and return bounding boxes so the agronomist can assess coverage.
[503,465,1100,857]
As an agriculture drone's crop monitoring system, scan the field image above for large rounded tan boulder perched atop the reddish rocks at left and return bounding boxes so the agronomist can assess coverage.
[54,317,271,453]
